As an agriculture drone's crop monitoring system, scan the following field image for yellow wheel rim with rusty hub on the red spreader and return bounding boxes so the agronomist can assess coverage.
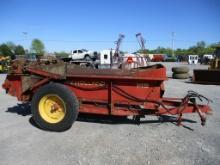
[38,94,66,123]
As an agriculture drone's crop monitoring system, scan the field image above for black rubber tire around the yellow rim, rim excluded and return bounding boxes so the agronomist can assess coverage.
[31,83,79,132]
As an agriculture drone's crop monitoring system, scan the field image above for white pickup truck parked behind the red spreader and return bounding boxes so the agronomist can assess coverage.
[69,49,97,61]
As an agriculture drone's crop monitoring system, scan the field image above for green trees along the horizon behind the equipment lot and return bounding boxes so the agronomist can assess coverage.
[0,39,220,57]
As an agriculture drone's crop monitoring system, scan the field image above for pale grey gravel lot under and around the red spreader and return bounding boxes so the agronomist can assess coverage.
[0,63,220,165]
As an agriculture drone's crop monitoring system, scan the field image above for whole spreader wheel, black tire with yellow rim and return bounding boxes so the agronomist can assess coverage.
[31,83,79,132]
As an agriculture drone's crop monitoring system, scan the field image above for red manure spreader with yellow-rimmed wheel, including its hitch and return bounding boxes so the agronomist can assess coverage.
[2,60,211,131]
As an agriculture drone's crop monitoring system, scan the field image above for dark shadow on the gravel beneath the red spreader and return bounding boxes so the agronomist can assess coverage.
[6,103,197,130]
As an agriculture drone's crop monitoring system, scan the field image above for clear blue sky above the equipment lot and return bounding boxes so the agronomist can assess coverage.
[0,0,220,52]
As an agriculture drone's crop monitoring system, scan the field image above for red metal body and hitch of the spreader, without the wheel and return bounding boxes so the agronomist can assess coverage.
[3,62,211,125]
